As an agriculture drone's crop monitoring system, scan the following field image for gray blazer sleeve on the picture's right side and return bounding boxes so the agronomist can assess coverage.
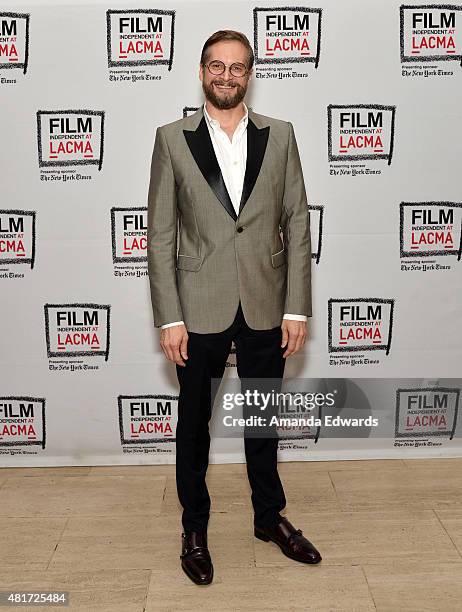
[281,122,312,317]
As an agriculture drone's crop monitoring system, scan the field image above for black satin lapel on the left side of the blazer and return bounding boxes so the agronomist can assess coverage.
[183,117,237,221]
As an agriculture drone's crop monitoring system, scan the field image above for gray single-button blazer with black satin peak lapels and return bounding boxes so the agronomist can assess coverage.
[147,107,312,333]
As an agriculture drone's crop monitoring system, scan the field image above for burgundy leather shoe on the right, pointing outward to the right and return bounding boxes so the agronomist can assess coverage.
[254,517,322,563]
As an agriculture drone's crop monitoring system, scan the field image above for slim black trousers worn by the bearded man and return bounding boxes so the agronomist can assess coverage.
[176,302,286,531]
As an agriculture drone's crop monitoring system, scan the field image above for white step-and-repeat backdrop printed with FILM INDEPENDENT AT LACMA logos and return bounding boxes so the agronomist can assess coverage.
[0,0,462,466]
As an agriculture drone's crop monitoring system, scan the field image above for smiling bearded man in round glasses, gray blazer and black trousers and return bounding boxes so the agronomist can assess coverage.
[148,30,321,584]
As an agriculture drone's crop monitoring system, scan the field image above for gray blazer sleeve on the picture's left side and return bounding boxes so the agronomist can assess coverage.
[147,127,183,327]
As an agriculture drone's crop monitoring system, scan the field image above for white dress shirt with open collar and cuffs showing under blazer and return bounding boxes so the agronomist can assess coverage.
[161,103,307,329]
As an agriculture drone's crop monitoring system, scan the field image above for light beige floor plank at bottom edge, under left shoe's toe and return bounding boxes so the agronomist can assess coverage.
[146,562,375,612]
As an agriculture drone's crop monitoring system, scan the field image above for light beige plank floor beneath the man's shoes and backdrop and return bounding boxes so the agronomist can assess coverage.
[0,459,462,612]
